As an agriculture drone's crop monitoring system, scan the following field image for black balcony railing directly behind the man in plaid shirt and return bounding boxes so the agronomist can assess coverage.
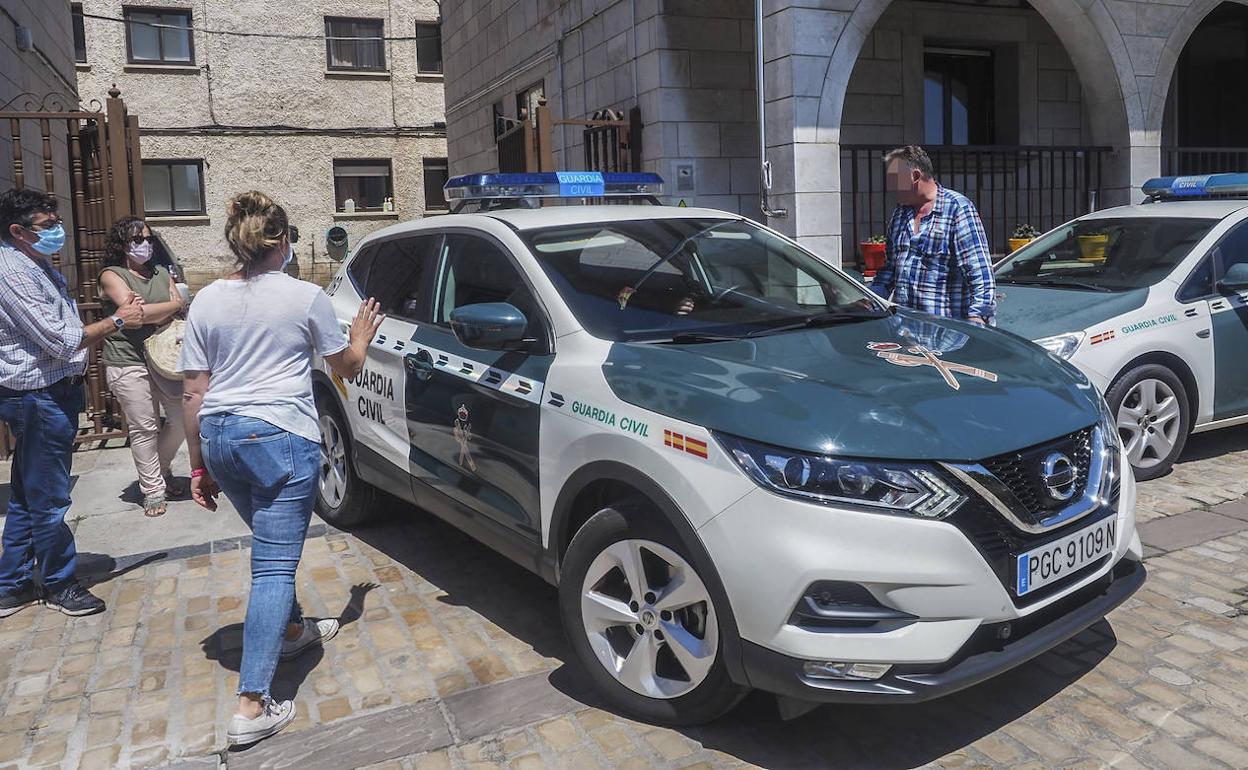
[841,145,1109,265]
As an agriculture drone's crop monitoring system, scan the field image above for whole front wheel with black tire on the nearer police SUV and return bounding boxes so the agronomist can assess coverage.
[559,505,749,725]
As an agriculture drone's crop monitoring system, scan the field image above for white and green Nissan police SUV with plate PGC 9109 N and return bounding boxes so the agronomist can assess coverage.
[316,173,1144,723]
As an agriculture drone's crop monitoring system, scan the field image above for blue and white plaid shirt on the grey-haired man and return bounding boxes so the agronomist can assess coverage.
[871,187,996,321]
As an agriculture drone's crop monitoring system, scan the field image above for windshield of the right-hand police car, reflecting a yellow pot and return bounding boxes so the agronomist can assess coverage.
[996,217,1217,291]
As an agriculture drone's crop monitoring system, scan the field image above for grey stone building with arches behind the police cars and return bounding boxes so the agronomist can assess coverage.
[443,0,1248,261]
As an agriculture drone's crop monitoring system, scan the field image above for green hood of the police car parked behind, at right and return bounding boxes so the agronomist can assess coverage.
[997,283,1148,339]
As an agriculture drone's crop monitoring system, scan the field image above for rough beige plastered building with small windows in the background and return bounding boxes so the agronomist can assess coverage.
[72,0,447,288]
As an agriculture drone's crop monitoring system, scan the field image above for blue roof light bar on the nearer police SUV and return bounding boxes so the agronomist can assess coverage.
[443,171,663,212]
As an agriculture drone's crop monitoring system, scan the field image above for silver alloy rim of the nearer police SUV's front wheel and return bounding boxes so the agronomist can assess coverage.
[580,539,719,699]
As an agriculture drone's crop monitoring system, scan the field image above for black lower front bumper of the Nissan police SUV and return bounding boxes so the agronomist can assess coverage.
[743,558,1146,703]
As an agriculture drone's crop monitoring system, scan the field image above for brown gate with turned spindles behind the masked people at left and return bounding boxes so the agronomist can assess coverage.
[0,86,144,457]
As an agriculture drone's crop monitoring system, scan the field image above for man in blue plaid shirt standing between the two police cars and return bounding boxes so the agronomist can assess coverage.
[871,145,996,326]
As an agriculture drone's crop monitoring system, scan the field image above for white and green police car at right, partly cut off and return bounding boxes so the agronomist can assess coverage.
[996,173,1248,479]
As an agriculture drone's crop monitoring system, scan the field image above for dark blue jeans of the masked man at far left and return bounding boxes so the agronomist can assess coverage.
[0,379,84,595]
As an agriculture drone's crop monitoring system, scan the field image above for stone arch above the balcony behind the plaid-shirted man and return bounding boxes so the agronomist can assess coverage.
[815,0,1143,147]
